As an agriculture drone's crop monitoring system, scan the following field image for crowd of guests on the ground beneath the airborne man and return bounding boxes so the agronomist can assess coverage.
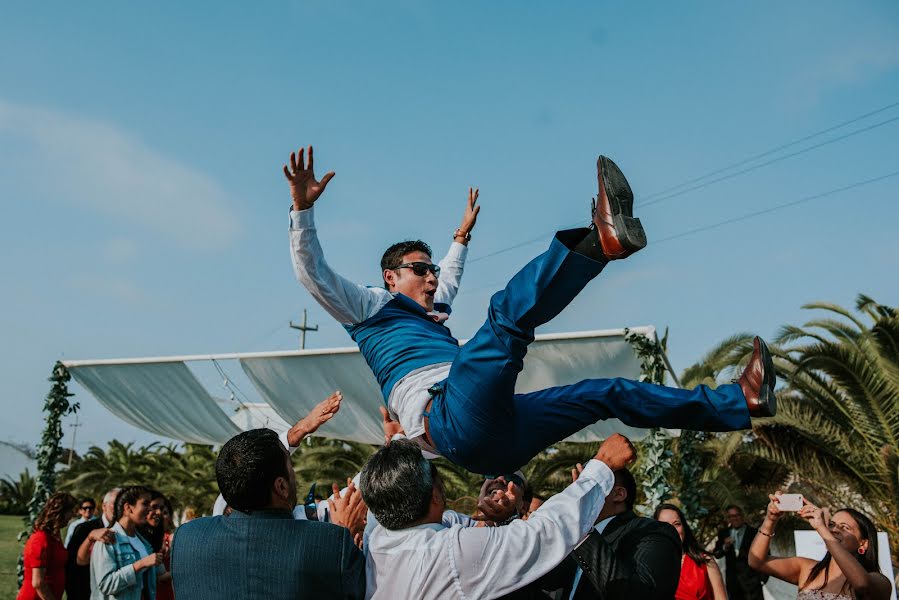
[18,394,890,600]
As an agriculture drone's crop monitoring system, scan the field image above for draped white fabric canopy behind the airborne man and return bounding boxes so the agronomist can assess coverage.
[63,326,672,444]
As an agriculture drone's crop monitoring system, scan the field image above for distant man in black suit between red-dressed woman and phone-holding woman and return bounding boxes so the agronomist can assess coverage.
[714,504,764,600]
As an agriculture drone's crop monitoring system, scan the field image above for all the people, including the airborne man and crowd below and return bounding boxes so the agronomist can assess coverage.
[20,146,890,600]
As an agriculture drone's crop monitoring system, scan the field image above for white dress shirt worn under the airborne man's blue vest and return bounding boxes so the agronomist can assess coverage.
[290,208,468,452]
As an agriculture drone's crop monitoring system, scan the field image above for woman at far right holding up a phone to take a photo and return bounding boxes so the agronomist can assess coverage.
[749,491,892,600]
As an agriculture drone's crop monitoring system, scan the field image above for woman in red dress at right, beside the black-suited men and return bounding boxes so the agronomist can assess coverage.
[653,504,727,600]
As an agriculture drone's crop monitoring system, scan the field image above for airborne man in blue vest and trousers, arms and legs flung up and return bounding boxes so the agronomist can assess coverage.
[284,146,775,475]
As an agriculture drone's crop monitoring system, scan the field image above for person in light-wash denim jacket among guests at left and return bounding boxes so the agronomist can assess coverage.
[91,485,162,600]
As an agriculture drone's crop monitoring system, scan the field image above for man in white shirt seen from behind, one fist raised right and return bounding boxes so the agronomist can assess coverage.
[359,434,634,600]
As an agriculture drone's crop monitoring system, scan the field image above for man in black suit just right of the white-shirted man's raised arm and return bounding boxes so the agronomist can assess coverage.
[538,465,682,600]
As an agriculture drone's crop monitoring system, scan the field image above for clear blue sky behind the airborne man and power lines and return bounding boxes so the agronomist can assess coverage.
[0,1,899,450]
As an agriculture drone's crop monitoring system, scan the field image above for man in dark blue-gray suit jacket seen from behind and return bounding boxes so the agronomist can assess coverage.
[172,429,365,600]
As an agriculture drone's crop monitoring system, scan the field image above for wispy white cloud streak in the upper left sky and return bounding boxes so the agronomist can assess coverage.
[0,99,240,250]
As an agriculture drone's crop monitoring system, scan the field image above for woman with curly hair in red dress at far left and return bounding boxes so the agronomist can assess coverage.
[16,492,78,600]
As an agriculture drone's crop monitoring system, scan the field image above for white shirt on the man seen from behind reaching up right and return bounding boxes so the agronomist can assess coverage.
[365,460,614,600]
